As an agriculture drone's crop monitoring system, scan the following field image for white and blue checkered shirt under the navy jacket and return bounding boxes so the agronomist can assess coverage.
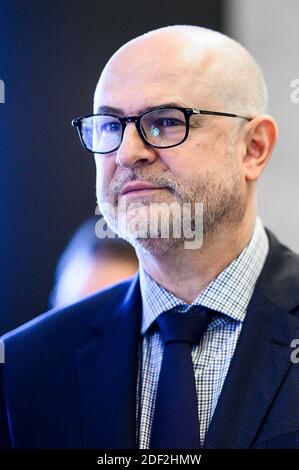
[136,218,269,449]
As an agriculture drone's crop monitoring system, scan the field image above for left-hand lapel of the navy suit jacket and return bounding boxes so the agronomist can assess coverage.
[77,275,141,449]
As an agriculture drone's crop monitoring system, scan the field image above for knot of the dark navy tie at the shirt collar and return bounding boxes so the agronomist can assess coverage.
[156,306,212,344]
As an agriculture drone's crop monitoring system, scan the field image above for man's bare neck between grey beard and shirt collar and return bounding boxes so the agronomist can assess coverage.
[137,207,256,304]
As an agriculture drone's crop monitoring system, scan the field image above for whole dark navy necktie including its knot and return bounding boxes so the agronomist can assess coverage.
[150,306,212,449]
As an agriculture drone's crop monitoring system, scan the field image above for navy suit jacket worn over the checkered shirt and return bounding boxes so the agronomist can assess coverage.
[0,232,299,449]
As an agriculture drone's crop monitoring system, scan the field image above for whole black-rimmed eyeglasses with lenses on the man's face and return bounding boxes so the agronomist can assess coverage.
[72,106,251,154]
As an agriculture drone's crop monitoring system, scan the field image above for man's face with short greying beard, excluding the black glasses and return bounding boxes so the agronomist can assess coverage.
[94,40,245,253]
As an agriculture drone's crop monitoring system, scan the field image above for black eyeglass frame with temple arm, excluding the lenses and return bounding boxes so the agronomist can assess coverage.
[72,106,253,155]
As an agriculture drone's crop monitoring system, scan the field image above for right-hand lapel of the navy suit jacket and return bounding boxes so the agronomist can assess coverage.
[204,282,299,449]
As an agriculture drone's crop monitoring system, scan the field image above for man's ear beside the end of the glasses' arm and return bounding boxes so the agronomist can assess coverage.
[243,114,278,181]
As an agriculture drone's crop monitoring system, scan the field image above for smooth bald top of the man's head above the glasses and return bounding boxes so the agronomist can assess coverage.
[95,25,267,117]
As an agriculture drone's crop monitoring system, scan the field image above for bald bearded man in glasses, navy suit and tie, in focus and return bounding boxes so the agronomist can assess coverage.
[1,26,299,448]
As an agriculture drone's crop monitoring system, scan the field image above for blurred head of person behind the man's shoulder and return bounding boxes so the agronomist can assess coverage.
[49,217,138,308]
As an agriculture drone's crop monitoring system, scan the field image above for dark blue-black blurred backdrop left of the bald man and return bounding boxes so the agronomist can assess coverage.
[0,0,225,334]
